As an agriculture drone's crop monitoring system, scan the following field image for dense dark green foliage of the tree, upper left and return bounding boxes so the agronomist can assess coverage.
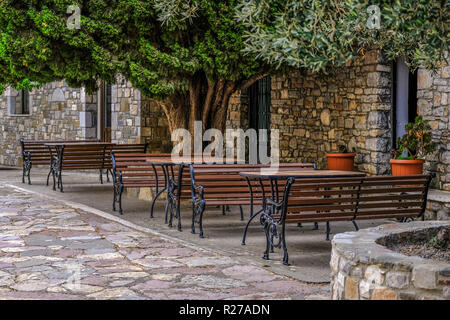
[0,0,270,99]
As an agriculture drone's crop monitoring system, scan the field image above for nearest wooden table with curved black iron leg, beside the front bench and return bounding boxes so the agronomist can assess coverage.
[240,170,366,244]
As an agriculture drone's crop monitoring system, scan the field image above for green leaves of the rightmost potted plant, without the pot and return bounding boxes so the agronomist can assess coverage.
[393,116,436,160]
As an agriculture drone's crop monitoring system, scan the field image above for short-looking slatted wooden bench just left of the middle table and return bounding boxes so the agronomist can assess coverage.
[111,149,175,218]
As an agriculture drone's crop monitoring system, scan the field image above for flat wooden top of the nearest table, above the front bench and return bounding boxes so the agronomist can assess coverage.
[239,170,366,179]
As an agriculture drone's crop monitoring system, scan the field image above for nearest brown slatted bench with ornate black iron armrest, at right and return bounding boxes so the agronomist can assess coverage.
[261,175,432,265]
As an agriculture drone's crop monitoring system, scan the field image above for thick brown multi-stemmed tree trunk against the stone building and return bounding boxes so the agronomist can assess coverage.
[159,72,265,144]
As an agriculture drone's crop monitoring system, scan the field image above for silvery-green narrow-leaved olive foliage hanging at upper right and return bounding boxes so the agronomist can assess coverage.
[236,0,450,71]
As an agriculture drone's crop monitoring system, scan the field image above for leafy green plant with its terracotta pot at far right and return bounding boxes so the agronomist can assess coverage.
[390,116,436,176]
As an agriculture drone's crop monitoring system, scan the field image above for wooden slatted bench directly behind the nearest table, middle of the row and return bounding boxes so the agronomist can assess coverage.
[186,163,315,238]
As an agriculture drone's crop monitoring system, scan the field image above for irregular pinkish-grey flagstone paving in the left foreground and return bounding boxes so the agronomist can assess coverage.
[0,185,329,299]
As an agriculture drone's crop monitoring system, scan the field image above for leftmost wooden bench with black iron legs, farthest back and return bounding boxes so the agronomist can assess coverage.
[20,140,98,185]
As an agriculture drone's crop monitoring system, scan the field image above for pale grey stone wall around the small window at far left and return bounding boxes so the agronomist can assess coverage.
[0,81,97,166]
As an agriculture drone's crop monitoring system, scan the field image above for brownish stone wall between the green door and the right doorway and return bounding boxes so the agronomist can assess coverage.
[271,51,392,174]
